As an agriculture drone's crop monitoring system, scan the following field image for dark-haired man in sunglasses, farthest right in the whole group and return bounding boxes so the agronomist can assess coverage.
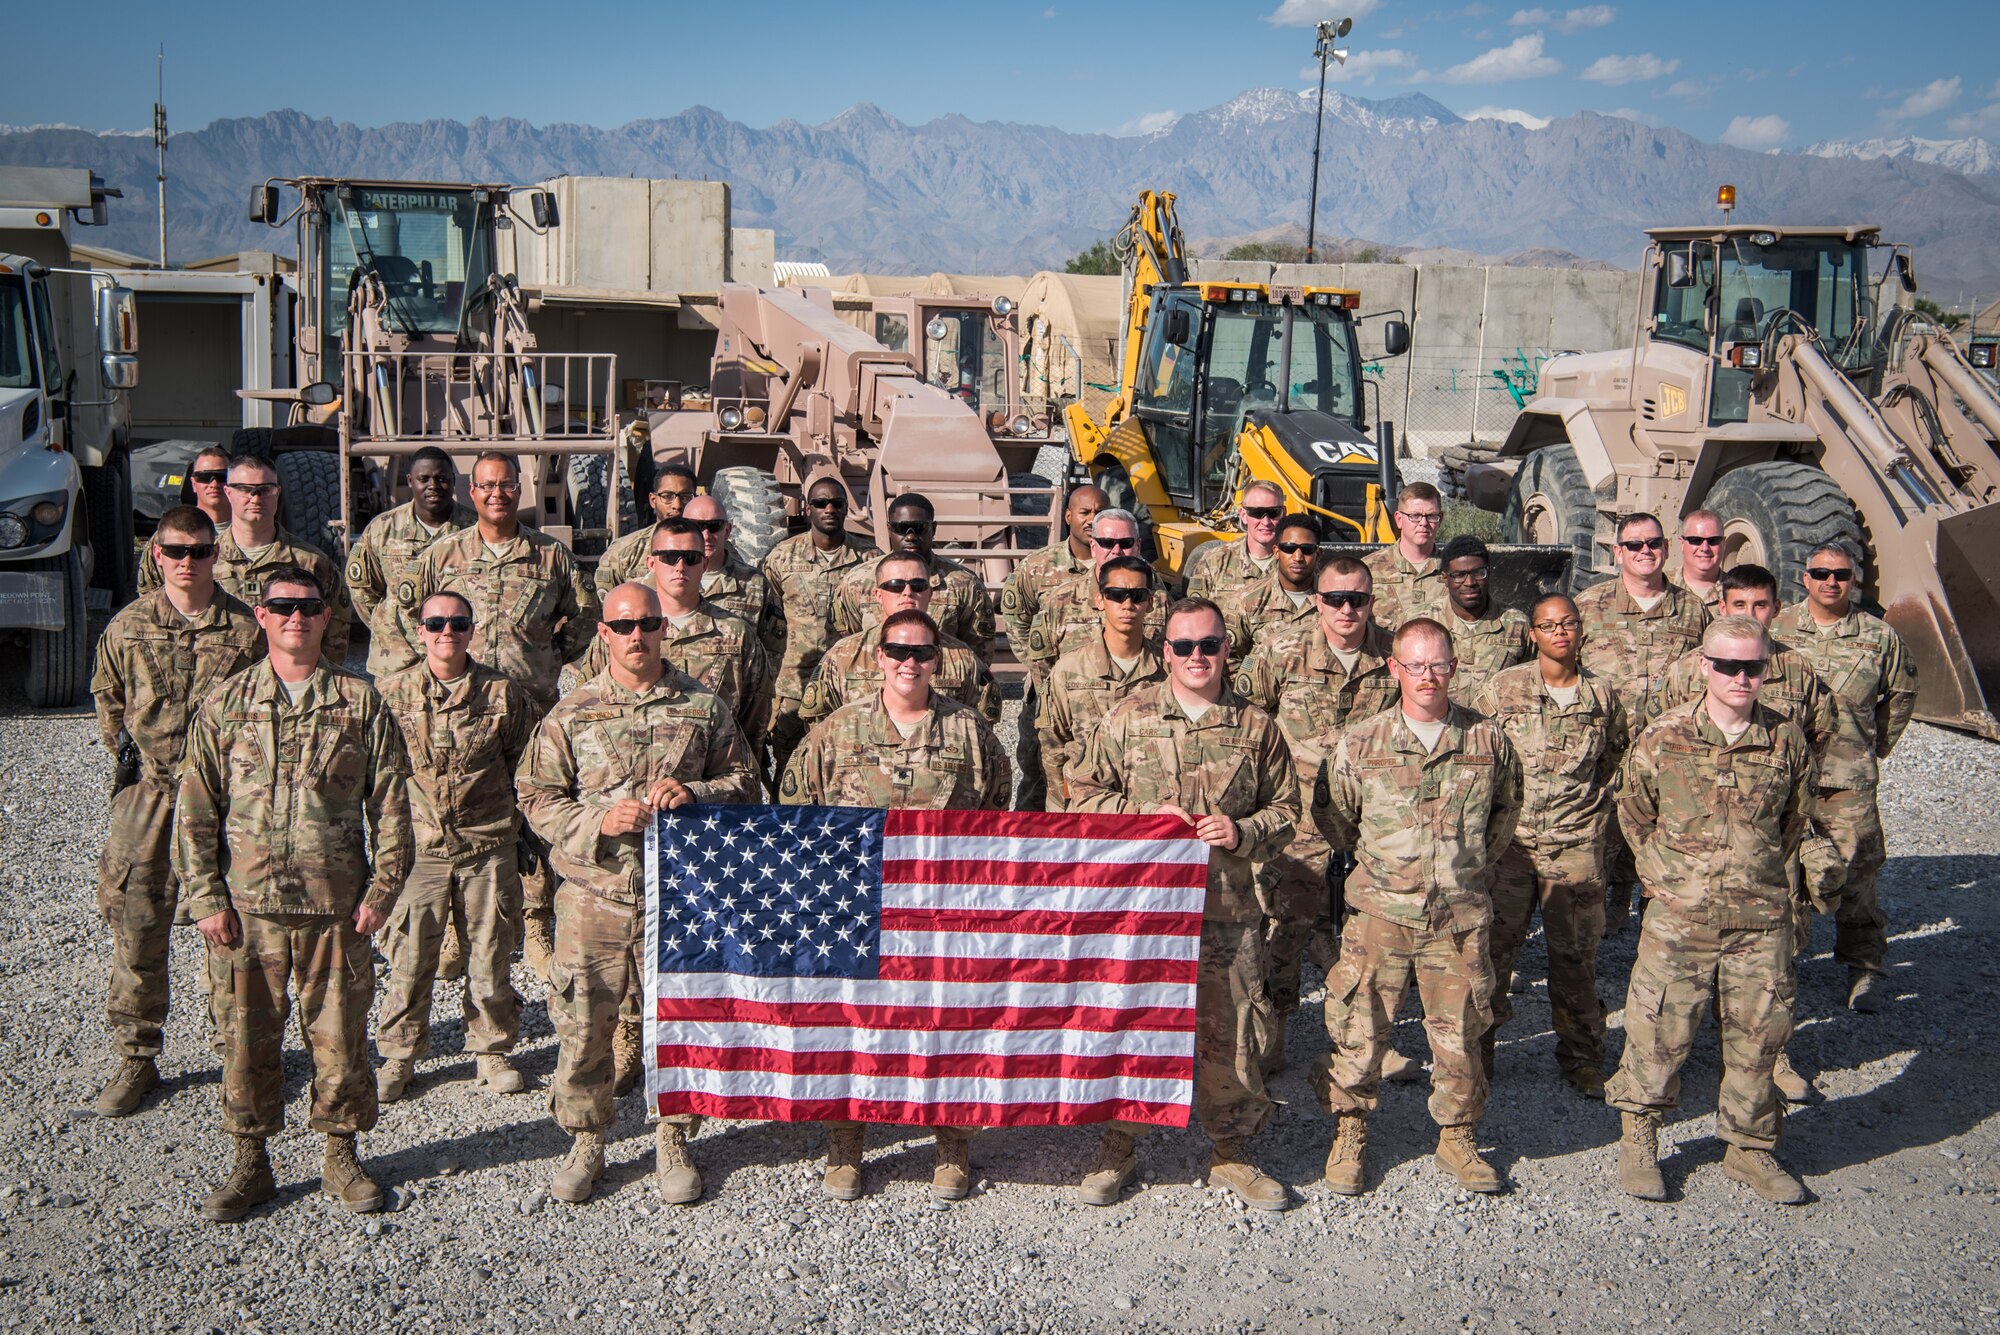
[1770,544,1916,1011]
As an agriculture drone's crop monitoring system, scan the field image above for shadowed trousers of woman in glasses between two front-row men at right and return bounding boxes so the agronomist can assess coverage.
[1488,843,1604,1071]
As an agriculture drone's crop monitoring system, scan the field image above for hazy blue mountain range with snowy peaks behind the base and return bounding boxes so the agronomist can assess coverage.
[11,88,2000,304]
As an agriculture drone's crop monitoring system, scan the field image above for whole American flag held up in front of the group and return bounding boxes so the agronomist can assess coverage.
[646,805,1208,1127]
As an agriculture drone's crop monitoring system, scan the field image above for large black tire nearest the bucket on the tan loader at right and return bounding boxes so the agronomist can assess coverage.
[1704,460,1866,604]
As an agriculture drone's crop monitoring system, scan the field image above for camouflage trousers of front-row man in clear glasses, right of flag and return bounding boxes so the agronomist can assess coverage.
[1312,913,1494,1127]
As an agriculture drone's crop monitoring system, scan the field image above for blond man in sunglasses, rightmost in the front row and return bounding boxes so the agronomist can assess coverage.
[1604,616,1812,1205]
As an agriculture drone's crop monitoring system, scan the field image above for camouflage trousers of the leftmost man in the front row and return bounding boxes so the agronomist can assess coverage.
[210,911,376,1139]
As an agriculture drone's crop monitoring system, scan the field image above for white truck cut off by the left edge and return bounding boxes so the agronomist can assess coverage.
[0,168,138,709]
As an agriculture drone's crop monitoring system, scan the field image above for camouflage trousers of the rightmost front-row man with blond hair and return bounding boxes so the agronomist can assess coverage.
[1604,903,1798,1149]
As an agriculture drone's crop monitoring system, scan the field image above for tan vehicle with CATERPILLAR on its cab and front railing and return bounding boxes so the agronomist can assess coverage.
[236,176,626,556]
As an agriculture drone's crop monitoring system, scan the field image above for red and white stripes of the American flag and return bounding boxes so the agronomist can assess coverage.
[646,807,1208,1127]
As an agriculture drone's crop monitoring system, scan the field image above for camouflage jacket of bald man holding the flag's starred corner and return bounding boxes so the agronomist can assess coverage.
[514,668,758,907]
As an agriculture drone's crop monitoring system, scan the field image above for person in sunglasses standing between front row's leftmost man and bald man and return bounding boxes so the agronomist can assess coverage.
[376,594,540,1103]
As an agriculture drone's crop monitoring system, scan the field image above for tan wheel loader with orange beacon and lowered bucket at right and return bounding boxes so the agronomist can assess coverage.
[1466,224,2000,737]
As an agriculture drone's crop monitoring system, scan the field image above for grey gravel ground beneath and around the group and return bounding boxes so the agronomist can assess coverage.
[0,619,2000,1333]
